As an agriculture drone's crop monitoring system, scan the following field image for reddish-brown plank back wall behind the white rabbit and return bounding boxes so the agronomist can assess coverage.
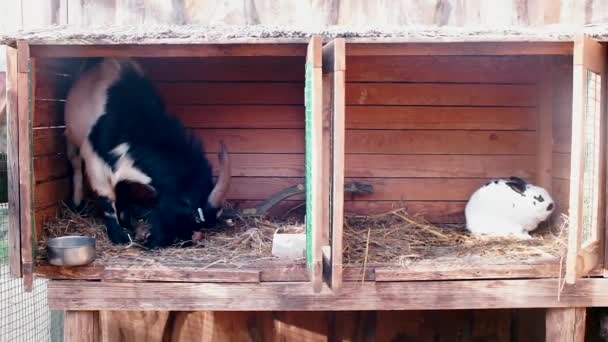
[345,54,540,222]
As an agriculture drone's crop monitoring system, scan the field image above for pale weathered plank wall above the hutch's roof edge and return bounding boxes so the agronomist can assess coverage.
[0,0,608,30]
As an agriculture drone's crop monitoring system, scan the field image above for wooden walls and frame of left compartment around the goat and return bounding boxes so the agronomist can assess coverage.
[4,37,326,289]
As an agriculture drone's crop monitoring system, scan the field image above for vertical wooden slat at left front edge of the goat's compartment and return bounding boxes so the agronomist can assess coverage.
[17,41,35,291]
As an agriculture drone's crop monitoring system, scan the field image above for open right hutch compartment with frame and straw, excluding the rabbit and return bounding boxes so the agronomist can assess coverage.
[324,36,606,287]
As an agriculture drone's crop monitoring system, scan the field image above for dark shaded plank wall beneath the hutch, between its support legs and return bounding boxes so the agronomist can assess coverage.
[95,309,544,342]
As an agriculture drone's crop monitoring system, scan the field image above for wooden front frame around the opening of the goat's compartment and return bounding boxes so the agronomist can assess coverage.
[11,37,322,289]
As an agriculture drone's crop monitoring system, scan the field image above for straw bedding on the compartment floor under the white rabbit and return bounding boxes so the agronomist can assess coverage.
[344,209,567,266]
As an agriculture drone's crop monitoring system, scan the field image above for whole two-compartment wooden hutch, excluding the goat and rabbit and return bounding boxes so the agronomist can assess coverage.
[8,29,608,324]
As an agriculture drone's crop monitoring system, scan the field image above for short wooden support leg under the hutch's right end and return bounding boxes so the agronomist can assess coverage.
[545,308,587,342]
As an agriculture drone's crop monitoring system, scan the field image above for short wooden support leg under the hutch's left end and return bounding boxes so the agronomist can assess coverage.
[63,311,100,342]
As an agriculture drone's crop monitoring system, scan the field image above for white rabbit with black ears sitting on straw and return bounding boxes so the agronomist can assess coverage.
[465,177,555,239]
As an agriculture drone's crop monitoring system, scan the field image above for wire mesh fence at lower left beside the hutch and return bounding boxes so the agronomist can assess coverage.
[0,162,63,342]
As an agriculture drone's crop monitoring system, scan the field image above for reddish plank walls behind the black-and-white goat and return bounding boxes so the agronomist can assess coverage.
[34,56,304,232]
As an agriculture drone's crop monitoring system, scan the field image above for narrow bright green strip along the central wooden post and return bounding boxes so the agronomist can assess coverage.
[304,63,313,270]
